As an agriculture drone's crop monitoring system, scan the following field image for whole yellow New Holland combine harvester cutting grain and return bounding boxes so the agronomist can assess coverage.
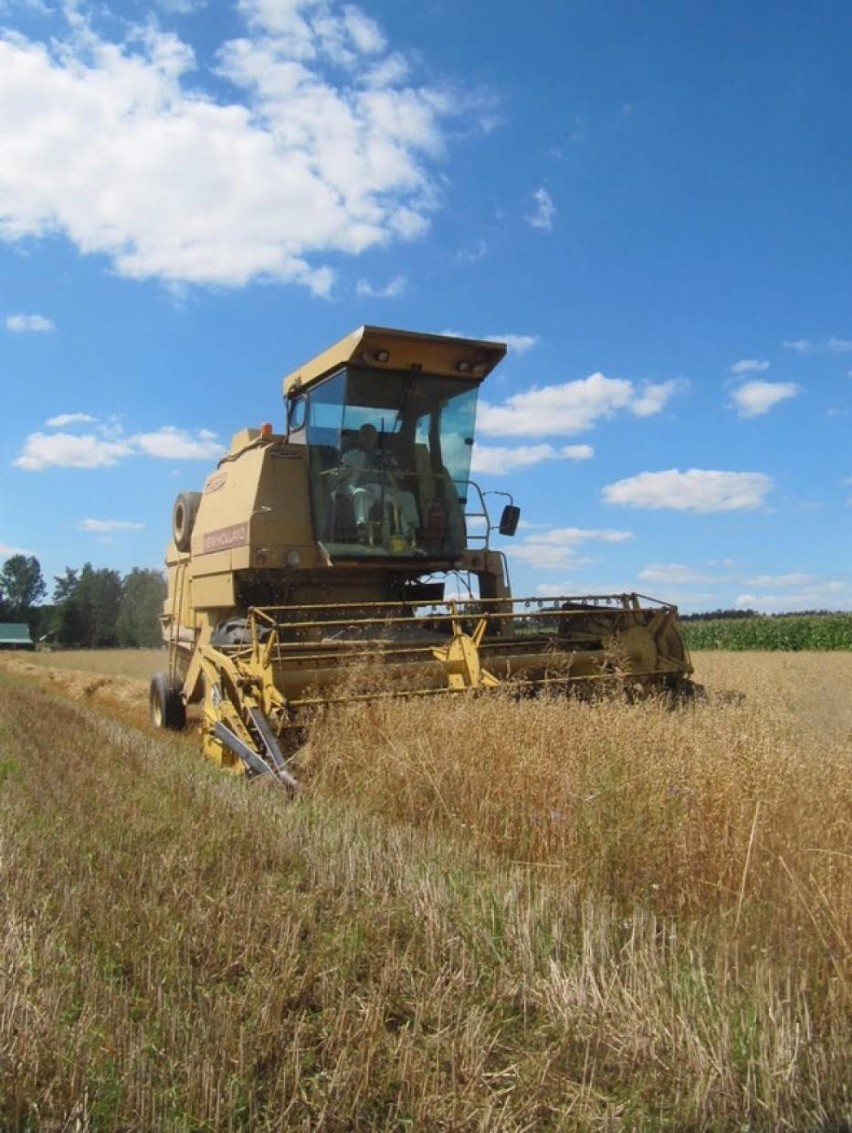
[151,326,692,790]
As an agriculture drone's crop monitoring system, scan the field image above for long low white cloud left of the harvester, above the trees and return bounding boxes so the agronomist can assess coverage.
[12,426,223,472]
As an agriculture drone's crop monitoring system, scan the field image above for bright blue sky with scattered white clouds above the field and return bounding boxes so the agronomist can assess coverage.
[0,0,852,612]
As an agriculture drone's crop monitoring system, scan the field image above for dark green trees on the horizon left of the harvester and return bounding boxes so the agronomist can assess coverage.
[0,555,165,649]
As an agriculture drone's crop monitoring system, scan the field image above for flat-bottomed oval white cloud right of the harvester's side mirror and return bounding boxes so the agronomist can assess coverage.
[603,468,773,512]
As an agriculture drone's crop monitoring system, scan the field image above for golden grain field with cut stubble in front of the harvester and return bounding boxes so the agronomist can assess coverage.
[0,651,852,1133]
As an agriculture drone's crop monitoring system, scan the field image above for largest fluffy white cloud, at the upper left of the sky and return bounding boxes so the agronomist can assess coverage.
[0,0,471,295]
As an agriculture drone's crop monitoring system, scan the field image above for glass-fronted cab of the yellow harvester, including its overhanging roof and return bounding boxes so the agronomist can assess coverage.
[284,326,505,570]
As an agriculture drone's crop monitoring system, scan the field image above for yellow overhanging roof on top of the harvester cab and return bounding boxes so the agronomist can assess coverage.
[284,326,506,397]
